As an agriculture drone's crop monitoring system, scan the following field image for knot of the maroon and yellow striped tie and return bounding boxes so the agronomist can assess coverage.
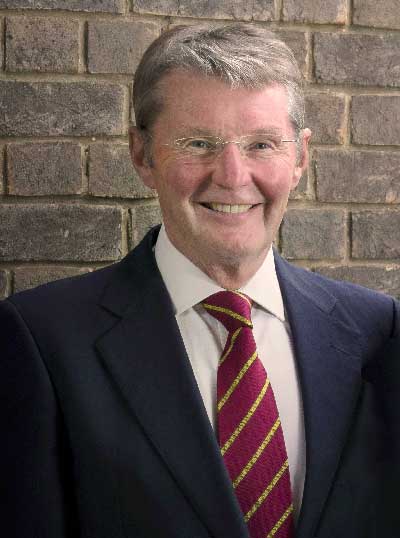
[201,291,253,332]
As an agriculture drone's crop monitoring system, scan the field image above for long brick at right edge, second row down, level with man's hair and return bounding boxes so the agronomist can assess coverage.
[314,33,400,87]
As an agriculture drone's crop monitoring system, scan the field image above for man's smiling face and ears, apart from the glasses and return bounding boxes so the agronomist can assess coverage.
[131,72,310,274]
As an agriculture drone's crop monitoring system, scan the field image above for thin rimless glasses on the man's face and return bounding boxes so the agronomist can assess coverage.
[163,133,299,162]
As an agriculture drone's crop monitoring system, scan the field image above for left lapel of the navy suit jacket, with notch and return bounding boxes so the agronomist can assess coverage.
[96,229,247,538]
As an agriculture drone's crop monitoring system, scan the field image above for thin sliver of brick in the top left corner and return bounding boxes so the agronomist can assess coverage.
[0,0,125,13]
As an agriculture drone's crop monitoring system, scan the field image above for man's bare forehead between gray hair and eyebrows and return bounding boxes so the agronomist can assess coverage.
[156,72,290,134]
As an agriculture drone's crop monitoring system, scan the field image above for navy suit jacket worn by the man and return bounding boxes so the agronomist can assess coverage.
[0,226,400,538]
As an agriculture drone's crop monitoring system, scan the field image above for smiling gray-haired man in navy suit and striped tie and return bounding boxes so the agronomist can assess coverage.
[0,24,400,538]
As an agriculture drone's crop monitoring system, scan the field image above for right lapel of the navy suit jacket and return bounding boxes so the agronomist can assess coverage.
[276,257,361,538]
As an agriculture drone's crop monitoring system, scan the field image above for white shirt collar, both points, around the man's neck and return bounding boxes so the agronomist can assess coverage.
[155,225,285,321]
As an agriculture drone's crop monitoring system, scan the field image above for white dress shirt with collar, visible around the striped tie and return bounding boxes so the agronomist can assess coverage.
[155,226,306,519]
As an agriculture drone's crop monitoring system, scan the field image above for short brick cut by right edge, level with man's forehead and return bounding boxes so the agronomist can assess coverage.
[350,95,400,146]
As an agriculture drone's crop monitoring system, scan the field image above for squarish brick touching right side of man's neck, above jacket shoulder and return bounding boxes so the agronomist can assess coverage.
[281,209,345,260]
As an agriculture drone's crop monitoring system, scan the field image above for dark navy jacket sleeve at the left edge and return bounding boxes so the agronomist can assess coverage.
[0,300,79,538]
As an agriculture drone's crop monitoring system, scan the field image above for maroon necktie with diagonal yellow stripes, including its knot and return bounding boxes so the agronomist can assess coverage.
[202,291,294,538]
